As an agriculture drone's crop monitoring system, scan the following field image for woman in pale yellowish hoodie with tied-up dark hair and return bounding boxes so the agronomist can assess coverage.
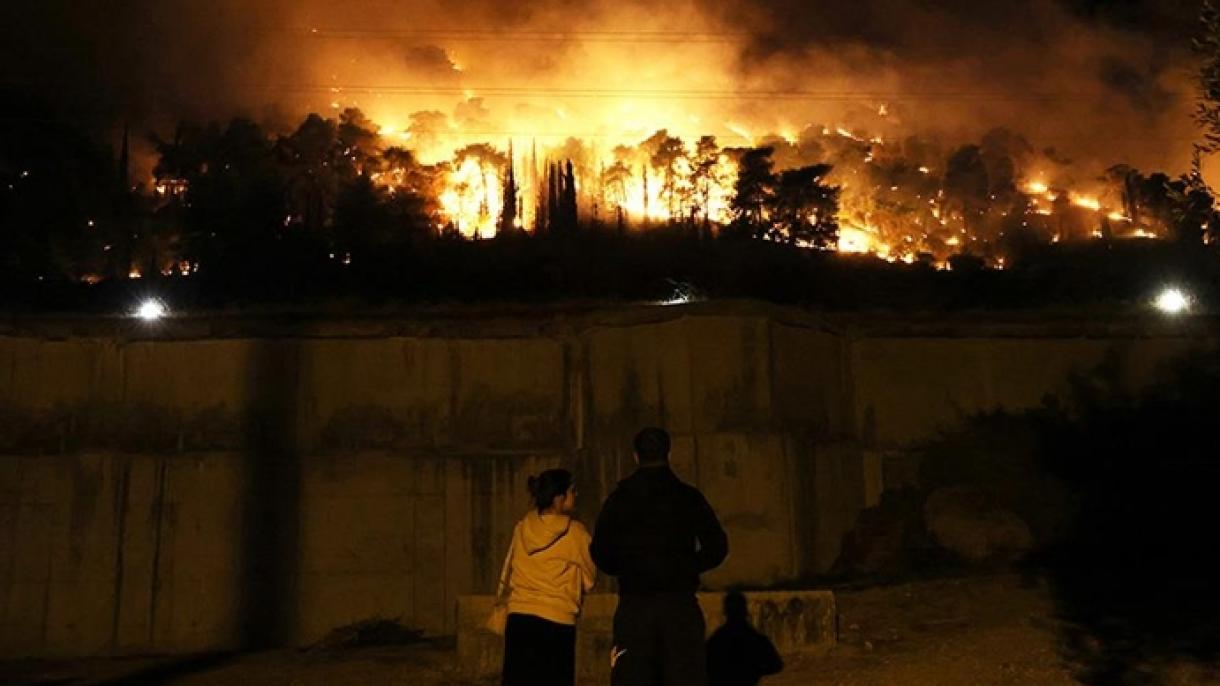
[500,469,597,686]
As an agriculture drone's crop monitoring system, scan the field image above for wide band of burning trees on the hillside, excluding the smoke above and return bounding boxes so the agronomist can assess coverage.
[133,98,1214,275]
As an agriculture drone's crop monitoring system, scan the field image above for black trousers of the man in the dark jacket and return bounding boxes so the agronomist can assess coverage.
[610,594,708,686]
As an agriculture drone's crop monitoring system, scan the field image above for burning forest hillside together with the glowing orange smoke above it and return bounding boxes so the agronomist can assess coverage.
[17,0,1220,281]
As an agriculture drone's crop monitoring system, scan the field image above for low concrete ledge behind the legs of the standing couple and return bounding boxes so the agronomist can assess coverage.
[458,591,837,684]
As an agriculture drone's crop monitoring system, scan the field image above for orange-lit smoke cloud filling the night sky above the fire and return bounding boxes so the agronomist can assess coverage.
[0,0,1196,173]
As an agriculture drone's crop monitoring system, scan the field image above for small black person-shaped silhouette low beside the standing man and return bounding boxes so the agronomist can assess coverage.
[708,591,783,686]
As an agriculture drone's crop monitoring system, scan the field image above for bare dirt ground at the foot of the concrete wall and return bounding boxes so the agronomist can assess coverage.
[0,575,1218,686]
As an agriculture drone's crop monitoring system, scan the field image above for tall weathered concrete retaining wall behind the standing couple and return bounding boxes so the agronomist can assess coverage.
[0,303,1210,657]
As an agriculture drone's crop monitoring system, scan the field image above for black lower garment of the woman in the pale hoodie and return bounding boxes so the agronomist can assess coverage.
[500,614,576,686]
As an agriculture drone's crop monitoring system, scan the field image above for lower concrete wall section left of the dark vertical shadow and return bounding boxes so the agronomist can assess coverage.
[0,454,242,657]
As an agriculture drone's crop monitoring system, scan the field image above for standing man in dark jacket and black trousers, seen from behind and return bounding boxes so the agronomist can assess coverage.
[589,428,728,686]
